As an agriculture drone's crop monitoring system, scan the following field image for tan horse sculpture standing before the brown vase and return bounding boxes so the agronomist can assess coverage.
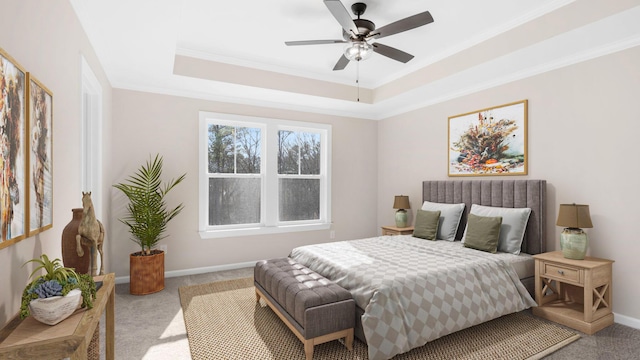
[76,191,104,275]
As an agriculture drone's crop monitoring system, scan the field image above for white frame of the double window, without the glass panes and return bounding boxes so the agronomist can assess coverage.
[198,111,331,239]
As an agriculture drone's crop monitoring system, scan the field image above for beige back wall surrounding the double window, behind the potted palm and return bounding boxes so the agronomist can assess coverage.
[105,90,378,276]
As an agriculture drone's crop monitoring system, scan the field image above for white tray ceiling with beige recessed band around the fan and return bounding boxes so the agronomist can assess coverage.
[70,0,640,119]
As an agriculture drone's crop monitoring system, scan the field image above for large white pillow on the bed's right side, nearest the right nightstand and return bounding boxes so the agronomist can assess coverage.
[462,204,531,255]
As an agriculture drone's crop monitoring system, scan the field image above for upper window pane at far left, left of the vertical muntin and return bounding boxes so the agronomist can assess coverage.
[208,125,234,174]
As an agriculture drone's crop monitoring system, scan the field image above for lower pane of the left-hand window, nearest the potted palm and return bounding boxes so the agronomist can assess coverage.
[209,178,261,225]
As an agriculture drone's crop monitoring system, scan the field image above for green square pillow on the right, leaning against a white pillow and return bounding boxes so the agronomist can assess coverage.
[464,213,502,254]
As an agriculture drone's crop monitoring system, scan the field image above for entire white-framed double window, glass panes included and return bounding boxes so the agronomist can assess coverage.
[199,112,331,238]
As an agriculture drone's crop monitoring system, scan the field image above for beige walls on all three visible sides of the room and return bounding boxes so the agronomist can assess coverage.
[0,0,640,334]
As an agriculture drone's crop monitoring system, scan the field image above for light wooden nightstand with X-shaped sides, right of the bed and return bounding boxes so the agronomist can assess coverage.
[533,251,613,335]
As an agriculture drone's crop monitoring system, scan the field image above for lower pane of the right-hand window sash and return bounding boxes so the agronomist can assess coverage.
[279,179,320,221]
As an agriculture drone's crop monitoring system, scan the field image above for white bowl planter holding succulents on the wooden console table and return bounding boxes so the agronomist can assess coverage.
[29,289,82,325]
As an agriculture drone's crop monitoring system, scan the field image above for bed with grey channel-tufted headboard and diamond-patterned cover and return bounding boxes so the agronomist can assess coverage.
[290,180,546,360]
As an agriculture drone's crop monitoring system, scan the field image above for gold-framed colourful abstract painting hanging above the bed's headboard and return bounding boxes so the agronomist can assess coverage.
[448,100,528,176]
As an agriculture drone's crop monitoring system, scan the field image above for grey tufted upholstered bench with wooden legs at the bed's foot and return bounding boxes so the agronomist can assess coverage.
[253,258,355,360]
